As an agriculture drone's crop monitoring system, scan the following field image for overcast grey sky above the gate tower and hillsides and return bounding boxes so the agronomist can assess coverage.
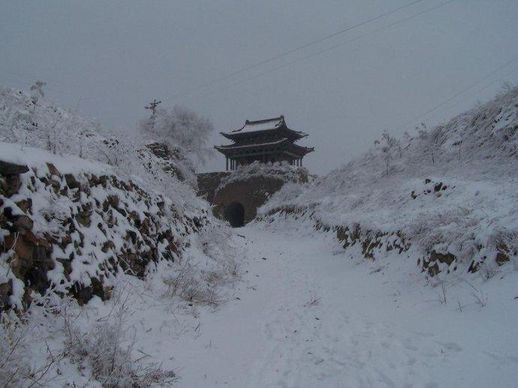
[0,0,518,173]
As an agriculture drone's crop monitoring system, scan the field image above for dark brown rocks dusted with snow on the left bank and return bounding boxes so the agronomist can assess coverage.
[0,161,207,310]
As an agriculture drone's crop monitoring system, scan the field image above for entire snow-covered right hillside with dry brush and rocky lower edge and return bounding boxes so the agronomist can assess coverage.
[261,88,518,276]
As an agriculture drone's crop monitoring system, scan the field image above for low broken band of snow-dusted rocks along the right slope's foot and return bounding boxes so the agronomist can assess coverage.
[259,179,518,277]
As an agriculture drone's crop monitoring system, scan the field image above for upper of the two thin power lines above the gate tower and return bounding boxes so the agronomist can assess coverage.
[174,0,432,98]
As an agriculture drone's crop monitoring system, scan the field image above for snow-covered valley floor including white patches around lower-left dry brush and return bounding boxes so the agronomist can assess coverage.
[5,183,518,388]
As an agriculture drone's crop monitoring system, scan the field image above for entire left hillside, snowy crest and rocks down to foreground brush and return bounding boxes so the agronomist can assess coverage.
[0,89,239,387]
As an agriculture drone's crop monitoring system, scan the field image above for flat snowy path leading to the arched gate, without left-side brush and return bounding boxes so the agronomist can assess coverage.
[169,225,518,387]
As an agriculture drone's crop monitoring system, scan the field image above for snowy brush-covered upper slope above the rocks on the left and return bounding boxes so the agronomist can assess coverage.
[0,86,196,190]
